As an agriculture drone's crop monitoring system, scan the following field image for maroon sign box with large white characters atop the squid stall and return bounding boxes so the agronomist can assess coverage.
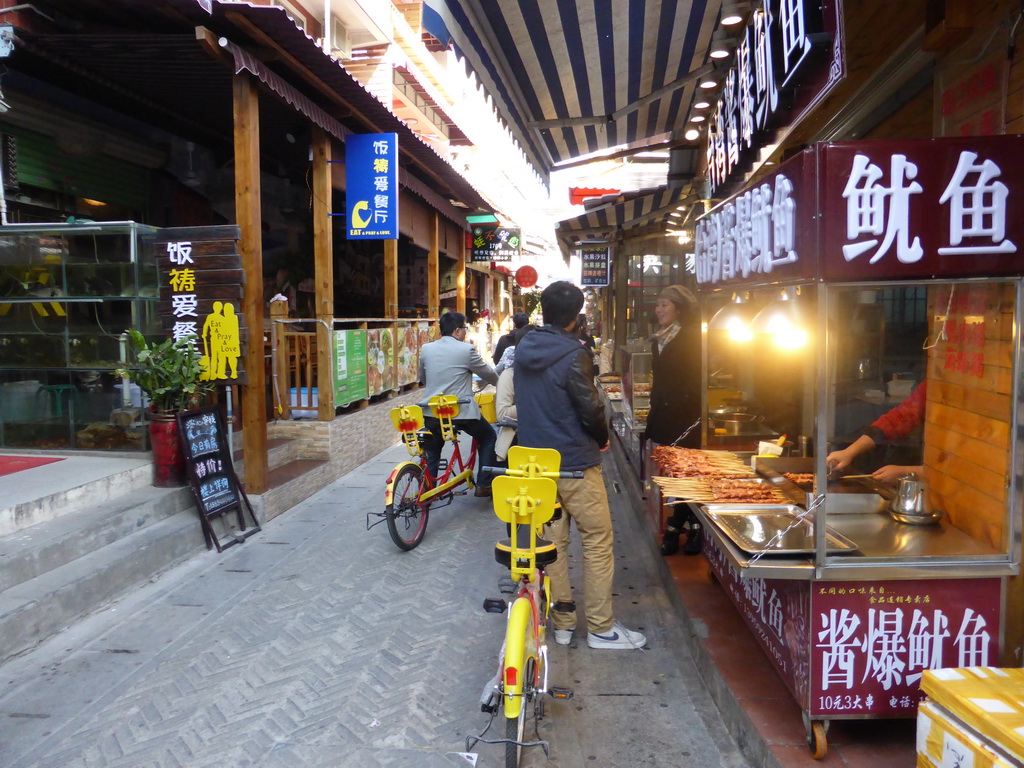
[695,136,1024,285]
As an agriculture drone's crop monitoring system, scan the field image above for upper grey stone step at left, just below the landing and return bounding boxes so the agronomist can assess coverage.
[0,485,193,591]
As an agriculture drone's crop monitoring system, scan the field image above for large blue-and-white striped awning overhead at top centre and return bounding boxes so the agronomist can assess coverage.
[423,0,721,183]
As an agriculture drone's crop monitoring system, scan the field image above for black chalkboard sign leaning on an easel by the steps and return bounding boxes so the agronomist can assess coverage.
[178,406,260,552]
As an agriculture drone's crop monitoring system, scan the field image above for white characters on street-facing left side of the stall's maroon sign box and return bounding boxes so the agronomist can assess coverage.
[695,173,798,283]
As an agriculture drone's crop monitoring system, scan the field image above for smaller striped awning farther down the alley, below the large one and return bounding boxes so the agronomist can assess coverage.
[556,186,692,250]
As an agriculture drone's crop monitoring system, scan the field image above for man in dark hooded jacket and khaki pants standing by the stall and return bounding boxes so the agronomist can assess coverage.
[513,282,647,648]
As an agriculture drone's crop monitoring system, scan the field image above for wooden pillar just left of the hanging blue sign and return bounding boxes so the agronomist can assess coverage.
[312,126,334,421]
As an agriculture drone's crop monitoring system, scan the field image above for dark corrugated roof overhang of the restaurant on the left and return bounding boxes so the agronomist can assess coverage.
[8,0,489,212]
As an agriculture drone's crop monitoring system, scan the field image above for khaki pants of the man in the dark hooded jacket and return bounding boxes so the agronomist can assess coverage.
[547,467,615,634]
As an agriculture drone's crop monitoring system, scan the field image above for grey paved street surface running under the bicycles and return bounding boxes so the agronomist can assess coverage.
[0,445,748,768]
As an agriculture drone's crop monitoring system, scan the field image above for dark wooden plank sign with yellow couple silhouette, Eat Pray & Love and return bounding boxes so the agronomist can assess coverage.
[151,226,247,384]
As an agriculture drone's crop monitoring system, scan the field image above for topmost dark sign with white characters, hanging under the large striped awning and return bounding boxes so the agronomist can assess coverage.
[707,0,846,196]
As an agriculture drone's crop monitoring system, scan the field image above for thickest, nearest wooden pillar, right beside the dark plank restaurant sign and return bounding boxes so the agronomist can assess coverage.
[231,73,267,494]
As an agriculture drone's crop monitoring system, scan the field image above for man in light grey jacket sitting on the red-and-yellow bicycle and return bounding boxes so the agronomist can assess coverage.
[420,312,498,496]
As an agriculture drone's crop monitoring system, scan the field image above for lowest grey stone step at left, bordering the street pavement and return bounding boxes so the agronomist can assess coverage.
[0,509,206,663]
